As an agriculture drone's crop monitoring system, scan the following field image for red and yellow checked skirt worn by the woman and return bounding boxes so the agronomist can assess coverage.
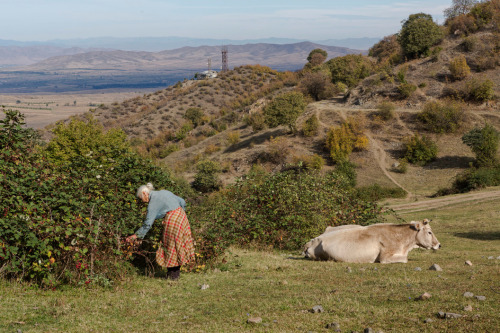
[156,207,194,268]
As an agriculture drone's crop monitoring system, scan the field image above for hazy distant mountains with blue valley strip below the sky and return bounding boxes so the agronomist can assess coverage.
[0,42,366,93]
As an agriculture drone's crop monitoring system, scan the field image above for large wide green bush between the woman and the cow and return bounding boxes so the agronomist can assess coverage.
[189,170,380,252]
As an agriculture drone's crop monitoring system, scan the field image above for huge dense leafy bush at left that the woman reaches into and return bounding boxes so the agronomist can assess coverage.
[0,111,191,287]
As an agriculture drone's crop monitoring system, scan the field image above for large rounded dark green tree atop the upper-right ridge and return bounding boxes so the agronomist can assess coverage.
[398,13,443,58]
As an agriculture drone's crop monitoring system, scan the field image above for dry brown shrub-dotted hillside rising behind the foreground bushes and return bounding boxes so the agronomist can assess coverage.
[71,15,500,198]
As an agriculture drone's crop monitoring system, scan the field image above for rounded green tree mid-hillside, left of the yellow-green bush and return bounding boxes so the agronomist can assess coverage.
[264,91,307,132]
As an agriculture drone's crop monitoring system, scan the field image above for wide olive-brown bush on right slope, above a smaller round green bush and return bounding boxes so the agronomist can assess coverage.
[417,101,465,133]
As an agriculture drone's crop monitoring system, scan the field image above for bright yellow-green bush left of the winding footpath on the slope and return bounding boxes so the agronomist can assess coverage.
[326,119,368,163]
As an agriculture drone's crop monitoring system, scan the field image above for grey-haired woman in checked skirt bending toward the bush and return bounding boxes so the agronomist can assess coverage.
[127,183,194,280]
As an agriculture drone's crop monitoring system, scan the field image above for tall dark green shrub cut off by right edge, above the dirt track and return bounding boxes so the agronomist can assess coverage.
[462,124,500,167]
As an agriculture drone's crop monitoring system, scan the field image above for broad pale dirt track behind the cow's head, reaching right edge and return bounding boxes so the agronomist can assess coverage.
[386,190,500,213]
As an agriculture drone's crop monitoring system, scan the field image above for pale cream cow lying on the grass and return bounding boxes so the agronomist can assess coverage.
[303,219,441,264]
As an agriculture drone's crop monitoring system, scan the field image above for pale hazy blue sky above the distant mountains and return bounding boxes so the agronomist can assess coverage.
[0,0,452,41]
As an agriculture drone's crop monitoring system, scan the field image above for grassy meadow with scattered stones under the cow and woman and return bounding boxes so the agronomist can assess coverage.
[0,196,500,332]
